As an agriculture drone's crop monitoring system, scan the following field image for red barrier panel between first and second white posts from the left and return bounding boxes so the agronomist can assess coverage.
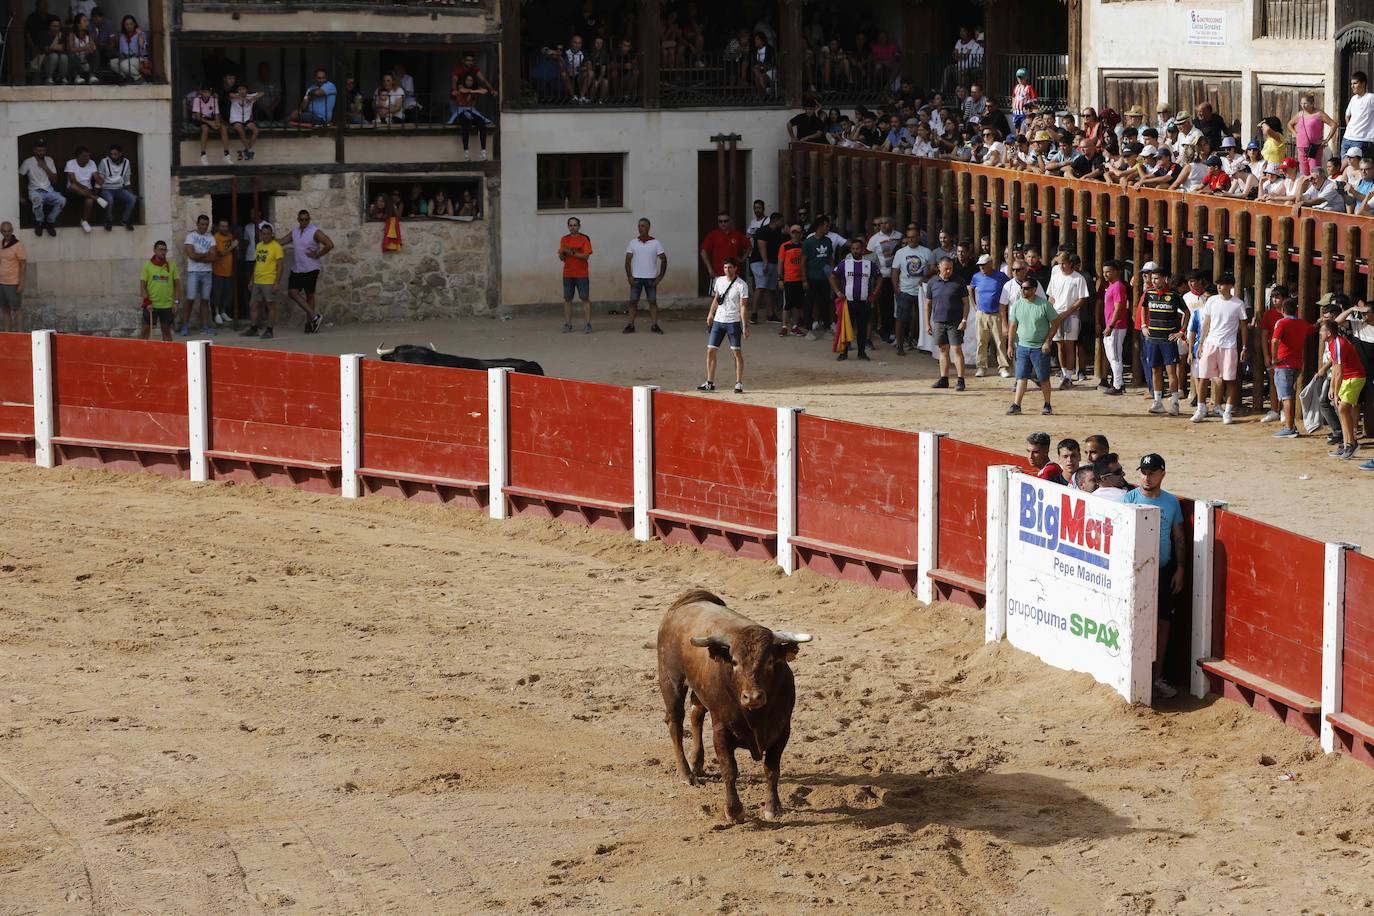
[52,334,191,477]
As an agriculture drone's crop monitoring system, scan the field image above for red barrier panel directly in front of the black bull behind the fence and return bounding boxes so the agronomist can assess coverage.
[359,360,488,508]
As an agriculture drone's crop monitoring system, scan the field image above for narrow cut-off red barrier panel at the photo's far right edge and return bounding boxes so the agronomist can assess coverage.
[1330,552,1374,764]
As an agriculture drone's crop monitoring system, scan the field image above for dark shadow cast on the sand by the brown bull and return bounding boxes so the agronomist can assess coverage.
[778,769,1154,846]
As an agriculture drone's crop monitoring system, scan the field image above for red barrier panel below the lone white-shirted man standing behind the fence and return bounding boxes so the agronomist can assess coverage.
[650,394,778,559]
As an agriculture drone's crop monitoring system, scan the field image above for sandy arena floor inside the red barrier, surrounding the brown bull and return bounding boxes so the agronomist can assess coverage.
[0,466,1374,916]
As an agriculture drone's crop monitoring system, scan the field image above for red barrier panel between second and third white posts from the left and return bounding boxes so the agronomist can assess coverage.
[205,346,341,493]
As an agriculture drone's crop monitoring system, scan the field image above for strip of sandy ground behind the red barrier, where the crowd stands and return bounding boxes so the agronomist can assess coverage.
[218,310,1374,549]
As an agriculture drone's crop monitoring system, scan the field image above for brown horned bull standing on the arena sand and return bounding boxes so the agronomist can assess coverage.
[658,589,811,820]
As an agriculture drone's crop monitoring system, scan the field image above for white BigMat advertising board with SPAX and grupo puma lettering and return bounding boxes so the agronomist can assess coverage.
[987,467,1160,703]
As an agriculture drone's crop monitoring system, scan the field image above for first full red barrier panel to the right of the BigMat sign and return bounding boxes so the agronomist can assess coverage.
[1202,509,1326,735]
